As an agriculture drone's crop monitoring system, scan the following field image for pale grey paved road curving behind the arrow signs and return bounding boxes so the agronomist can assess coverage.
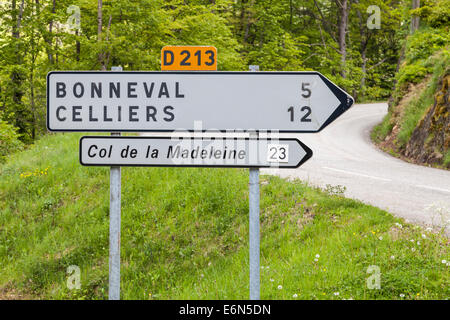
[262,103,450,234]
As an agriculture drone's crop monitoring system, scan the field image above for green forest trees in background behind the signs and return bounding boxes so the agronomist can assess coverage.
[0,0,450,148]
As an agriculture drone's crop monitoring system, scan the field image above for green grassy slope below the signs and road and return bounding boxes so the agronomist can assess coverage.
[0,134,450,299]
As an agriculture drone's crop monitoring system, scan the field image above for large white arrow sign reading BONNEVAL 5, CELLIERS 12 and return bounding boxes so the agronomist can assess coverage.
[47,71,353,132]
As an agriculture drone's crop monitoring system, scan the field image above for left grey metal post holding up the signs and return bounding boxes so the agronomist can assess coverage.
[108,67,122,300]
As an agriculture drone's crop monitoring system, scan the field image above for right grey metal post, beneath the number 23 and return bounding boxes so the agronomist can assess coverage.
[248,65,260,300]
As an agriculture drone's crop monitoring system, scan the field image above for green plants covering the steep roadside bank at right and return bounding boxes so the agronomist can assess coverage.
[371,15,450,162]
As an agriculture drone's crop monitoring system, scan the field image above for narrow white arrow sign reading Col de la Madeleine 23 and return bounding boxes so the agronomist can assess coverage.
[80,136,312,168]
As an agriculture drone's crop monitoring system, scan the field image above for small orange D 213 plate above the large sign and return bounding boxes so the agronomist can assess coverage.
[161,46,217,71]
